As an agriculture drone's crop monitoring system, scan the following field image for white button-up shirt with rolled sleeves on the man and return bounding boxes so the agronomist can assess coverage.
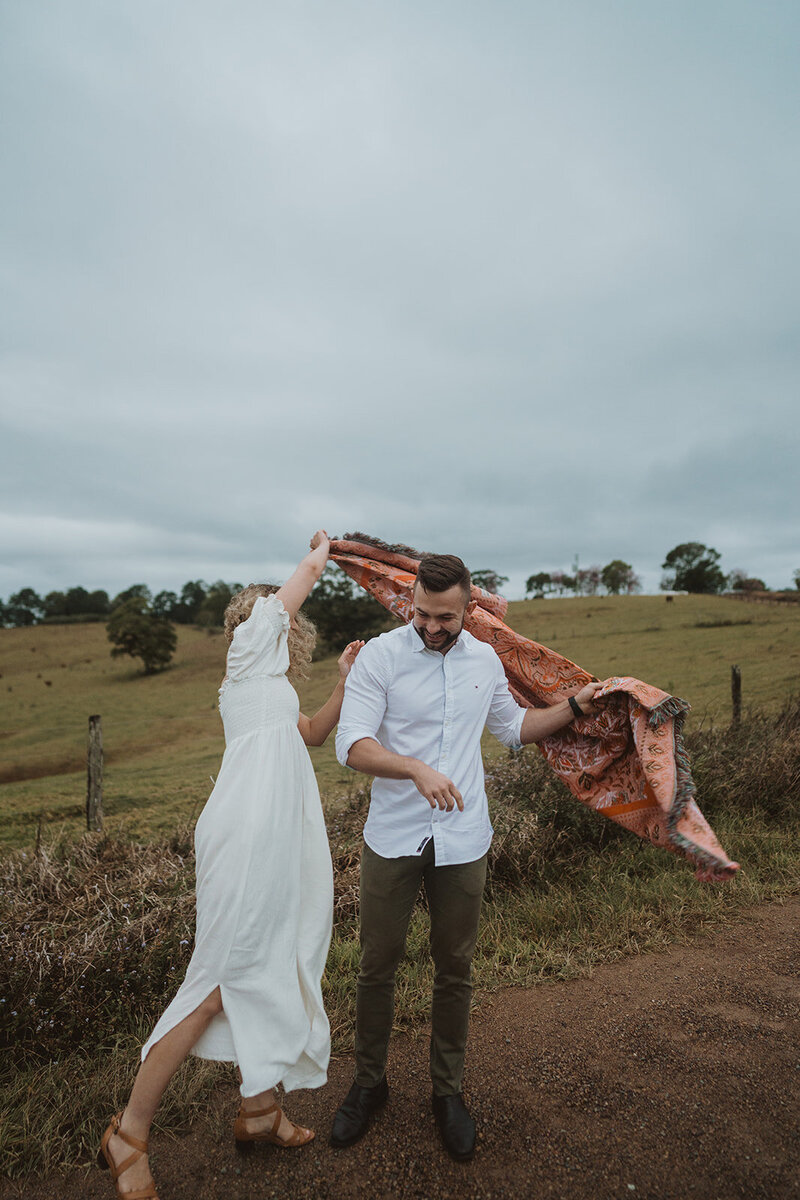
[336,624,525,866]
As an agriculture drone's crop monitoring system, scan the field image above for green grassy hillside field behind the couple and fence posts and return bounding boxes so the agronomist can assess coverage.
[0,596,800,847]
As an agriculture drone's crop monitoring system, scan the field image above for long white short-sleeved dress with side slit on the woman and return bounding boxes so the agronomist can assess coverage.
[142,595,333,1096]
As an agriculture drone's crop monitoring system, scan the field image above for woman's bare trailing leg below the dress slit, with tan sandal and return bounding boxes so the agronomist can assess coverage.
[108,988,222,1192]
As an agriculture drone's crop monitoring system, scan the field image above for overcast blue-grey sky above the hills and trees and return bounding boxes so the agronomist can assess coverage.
[0,0,800,599]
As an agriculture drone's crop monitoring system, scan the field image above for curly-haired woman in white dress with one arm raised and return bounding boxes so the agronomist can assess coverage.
[101,530,363,1200]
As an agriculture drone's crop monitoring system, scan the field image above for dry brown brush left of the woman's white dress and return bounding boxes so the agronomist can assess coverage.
[0,830,194,1062]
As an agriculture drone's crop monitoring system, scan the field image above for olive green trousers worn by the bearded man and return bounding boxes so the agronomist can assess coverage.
[355,839,487,1096]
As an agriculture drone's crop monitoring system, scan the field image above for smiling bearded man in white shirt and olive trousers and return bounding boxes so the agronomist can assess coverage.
[331,554,600,1159]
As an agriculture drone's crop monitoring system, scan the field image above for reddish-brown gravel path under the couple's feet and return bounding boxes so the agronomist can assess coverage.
[0,898,800,1200]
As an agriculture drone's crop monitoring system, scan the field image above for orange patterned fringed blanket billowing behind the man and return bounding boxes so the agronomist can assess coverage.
[331,534,739,882]
